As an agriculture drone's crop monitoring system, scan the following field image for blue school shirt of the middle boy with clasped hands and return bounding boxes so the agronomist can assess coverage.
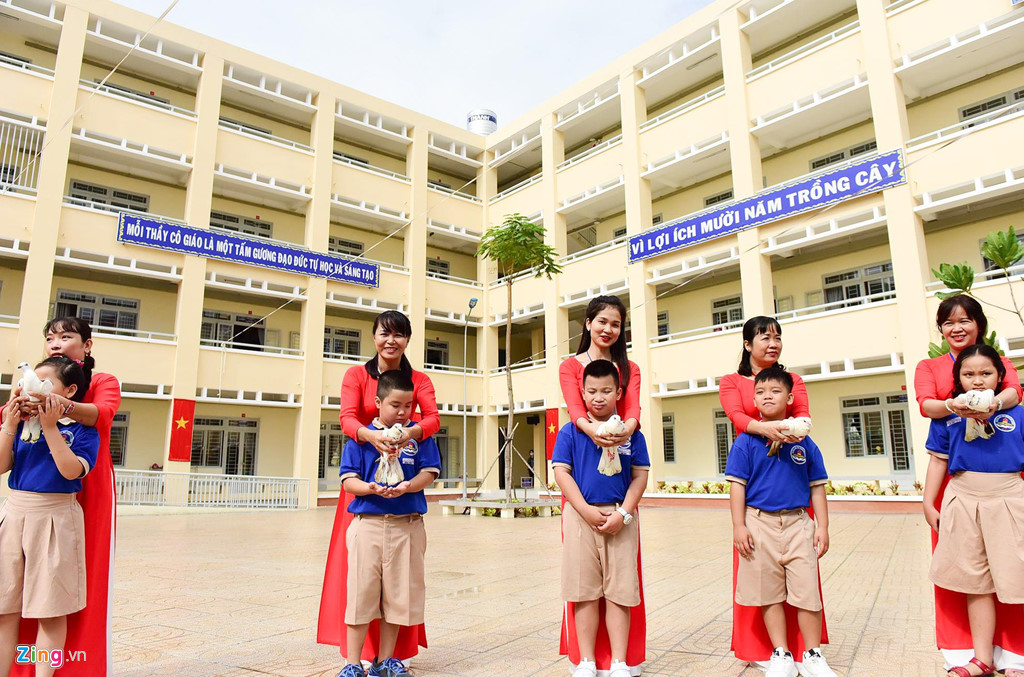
[551,423,650,505]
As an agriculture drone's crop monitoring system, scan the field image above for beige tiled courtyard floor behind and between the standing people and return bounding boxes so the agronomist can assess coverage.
[114,506,944,677]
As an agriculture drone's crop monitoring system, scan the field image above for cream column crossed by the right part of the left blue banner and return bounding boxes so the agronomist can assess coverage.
[292,94,335,495]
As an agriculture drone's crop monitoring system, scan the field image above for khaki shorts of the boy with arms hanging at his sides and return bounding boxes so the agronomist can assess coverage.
[736,506,821,611]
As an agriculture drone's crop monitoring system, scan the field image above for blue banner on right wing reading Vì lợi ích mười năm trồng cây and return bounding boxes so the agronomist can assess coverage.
[630,150,906,263]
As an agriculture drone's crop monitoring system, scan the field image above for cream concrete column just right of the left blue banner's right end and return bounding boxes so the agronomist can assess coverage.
[403,127,430,369]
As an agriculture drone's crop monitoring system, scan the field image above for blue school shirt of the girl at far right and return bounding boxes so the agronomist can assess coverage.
[925,407,1024,474]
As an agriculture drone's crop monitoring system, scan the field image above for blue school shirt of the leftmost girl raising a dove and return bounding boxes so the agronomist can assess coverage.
[7,421,99,494]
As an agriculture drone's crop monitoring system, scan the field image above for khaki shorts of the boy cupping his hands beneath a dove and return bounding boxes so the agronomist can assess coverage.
[345,514,427,626]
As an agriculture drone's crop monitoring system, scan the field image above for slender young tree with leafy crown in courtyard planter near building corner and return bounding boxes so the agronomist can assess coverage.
[476,212,562,502]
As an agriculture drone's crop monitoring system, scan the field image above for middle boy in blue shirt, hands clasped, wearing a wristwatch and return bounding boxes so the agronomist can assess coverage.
[551,359,650,677]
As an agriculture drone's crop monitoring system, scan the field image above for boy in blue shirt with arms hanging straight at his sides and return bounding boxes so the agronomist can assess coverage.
[725,367,836,677]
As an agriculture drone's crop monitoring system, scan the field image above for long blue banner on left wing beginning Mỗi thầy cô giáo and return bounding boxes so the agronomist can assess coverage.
[118,212,380,287]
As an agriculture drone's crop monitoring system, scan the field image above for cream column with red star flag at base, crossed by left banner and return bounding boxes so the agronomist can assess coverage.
[164,54,224,472]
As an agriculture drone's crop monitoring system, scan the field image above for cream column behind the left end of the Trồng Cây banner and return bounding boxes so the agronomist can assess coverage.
[618,71,665,483]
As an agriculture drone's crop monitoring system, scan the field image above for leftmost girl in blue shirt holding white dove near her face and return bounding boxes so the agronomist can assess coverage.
[0,355,99,674]
